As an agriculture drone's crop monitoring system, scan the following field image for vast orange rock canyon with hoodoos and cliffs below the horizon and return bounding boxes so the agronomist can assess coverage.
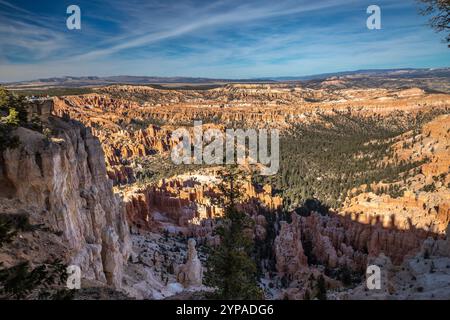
[0,79,450,299]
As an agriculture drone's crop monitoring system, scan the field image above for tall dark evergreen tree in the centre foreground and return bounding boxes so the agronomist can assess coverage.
[205,172,263,300]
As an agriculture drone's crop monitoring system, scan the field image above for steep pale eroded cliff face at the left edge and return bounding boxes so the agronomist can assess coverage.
[0,102,131,287]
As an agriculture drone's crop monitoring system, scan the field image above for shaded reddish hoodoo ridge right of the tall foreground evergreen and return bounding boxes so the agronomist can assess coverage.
[275,213,436,280]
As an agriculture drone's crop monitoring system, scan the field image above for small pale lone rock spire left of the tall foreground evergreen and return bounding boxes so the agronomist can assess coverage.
[177,239,203,287]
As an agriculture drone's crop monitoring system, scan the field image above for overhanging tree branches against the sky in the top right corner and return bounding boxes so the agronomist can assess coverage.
[419,0,450,48]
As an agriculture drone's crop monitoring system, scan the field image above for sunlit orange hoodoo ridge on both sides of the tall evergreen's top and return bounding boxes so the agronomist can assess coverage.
[121,173,282,235]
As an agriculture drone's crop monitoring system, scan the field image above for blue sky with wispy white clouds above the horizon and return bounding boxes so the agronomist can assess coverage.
[0,0,450,82]
